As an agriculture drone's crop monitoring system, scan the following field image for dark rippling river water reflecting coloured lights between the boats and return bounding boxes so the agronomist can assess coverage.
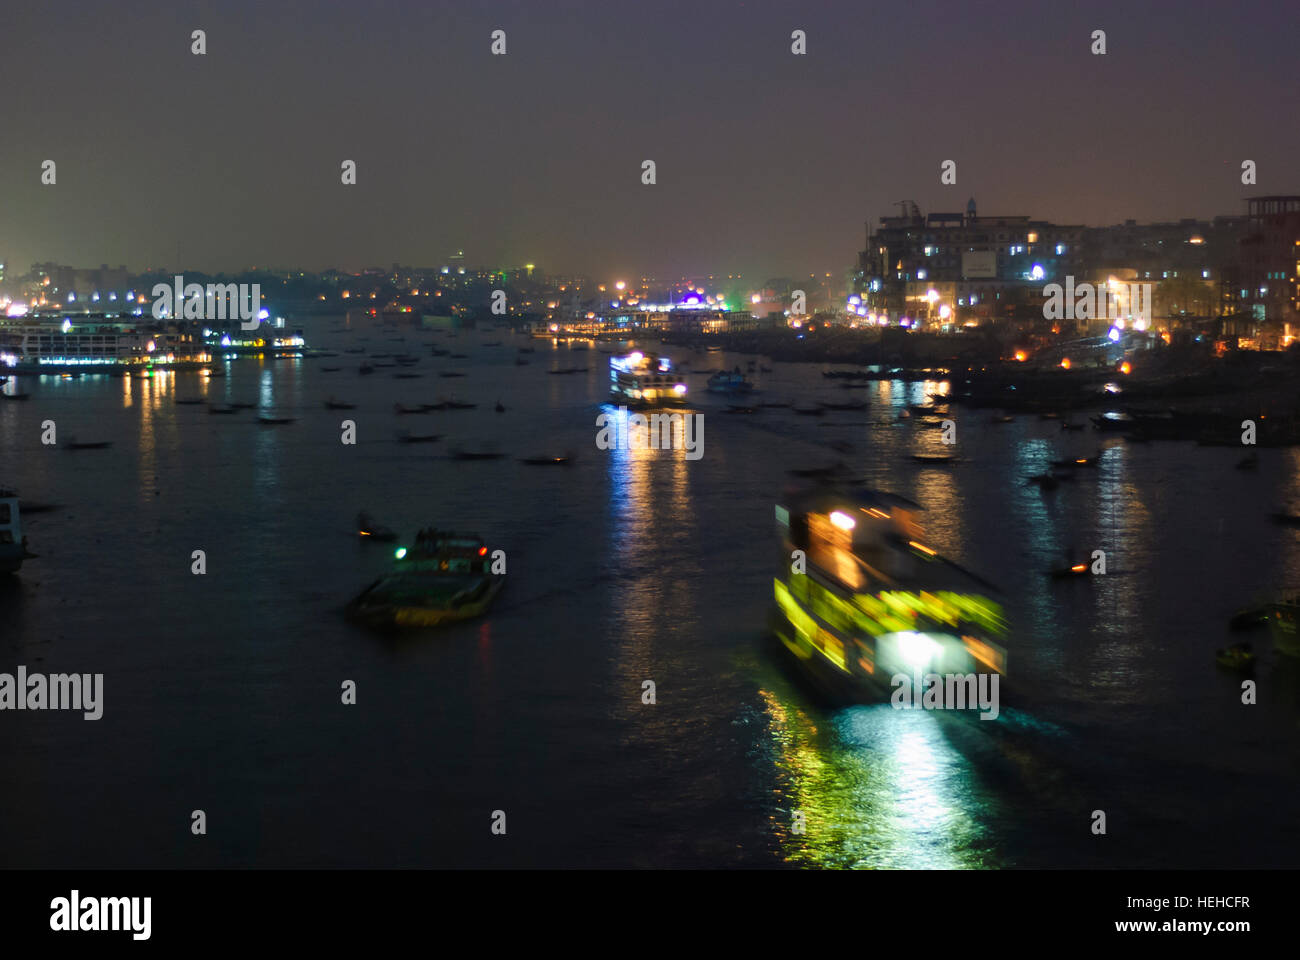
[0,321,1300,868]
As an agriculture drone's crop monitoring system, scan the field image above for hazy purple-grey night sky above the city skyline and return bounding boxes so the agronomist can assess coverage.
[0,0,1300,278]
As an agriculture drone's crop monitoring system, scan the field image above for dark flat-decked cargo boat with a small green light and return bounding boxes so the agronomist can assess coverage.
[347,528,506,628]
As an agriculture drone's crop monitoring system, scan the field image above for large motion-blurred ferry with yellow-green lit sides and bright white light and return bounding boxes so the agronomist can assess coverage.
[772,488,1006,700]
